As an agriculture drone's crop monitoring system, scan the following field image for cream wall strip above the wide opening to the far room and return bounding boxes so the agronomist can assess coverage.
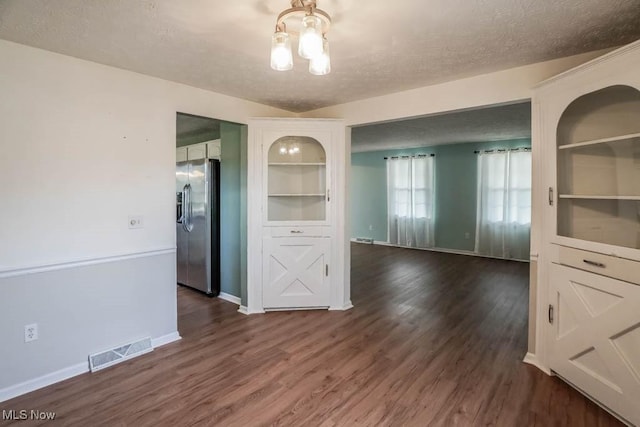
[303,49,610,126]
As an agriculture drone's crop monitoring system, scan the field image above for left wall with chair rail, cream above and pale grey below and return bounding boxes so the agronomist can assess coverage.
[0,41,291,400]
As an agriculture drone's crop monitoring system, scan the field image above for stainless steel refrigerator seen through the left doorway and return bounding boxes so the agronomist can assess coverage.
[176,159,220,296]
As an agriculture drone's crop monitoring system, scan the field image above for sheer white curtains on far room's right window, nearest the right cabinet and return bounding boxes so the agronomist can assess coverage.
[475,149,531,259]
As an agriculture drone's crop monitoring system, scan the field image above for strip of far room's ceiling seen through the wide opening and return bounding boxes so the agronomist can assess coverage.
[351,102,531,152]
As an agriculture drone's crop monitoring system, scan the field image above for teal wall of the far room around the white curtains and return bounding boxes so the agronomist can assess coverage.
[351,139,531,251]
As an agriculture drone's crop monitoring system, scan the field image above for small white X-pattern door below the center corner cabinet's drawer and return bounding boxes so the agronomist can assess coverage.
[263,237,330,309]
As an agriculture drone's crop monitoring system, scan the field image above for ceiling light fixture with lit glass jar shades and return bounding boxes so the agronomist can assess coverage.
[271,0,331,76]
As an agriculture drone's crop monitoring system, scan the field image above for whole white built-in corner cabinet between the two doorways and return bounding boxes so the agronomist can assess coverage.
[248,119,350,312]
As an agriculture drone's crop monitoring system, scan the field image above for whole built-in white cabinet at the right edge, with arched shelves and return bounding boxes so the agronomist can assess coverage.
[533,43,640,425]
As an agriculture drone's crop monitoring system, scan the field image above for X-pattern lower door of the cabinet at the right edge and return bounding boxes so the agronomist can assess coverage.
[549,264,640,425]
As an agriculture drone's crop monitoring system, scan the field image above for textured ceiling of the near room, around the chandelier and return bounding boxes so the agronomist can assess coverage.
[0,0,640,112]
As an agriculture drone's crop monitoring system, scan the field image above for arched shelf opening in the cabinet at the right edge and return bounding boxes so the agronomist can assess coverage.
[557,86,640,249]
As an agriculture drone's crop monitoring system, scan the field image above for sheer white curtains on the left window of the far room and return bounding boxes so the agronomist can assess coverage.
[387,156,435,248]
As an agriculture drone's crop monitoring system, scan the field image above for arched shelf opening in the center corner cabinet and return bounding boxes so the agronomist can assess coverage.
[267,136,329,221]
